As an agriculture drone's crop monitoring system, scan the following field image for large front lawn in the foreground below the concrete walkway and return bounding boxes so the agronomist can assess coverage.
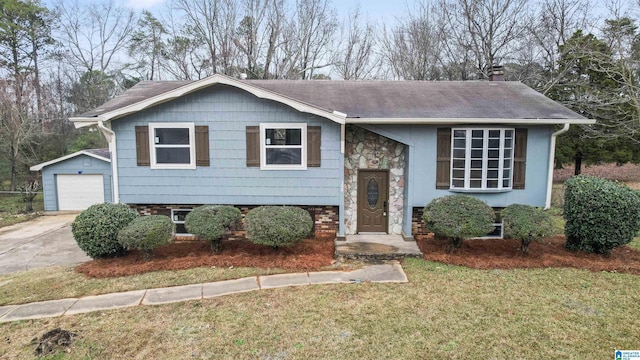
[0,260,640,359]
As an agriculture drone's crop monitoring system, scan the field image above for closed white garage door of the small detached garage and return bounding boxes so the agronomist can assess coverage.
[57,175,104,210]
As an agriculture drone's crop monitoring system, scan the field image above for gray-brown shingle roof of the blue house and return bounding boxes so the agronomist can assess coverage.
[83,80,585,119]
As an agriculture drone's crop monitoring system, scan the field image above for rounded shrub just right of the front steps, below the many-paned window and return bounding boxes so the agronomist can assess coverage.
[422,194,495,251]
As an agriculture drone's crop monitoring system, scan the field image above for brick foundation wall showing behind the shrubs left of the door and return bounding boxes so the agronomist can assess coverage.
[129,204,339,240]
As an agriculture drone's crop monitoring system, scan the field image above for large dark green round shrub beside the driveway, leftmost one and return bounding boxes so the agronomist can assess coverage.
[71,203,138,259]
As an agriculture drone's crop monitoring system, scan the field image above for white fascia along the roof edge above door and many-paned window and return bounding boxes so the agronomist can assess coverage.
[347,118,596,125]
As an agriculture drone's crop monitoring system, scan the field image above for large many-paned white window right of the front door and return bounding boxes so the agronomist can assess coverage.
[451,128,514,191]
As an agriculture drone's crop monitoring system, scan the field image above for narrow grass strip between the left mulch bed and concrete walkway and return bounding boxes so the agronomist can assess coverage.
[0,267,285,306]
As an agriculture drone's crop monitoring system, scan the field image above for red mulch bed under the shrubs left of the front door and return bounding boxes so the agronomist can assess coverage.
[76,237,335,278]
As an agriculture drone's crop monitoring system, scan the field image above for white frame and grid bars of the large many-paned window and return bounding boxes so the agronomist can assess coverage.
[449,128,516,192]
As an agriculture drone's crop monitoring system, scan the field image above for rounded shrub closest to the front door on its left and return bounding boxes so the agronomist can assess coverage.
[245,206,313,248]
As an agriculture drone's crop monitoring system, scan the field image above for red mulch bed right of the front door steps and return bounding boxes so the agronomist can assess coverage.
[416,235,640,275]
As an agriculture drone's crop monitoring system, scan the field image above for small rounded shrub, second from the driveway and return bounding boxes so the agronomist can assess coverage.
[118,215,173,260]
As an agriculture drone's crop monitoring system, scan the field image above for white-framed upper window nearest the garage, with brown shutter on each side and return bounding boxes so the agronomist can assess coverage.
[149,123,196,169]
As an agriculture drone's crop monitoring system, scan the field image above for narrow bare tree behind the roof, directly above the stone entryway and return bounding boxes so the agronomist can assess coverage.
[334,6,379,80]
